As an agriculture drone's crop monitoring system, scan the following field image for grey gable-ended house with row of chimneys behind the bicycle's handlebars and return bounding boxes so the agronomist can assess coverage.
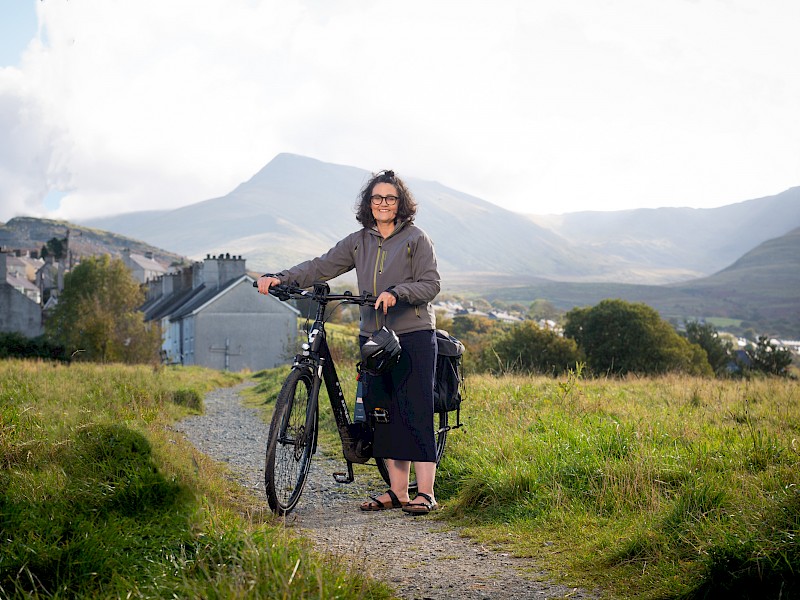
[141,255,299,371]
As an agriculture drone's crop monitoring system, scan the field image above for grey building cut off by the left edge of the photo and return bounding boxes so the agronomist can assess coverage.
[0,252,43,338]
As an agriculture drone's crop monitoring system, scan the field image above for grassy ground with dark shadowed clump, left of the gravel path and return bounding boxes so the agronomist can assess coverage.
[0,361,389,598]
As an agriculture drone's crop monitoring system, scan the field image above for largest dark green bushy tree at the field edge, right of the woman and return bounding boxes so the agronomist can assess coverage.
[564,299,712,375]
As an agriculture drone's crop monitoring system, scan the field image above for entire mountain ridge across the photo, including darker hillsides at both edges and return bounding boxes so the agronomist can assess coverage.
[0,154,800,336]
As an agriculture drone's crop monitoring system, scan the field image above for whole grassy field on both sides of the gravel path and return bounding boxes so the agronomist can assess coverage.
[0,361,800,599]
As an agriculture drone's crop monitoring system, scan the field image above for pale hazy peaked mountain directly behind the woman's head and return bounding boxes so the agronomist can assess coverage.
[76,154,613,278]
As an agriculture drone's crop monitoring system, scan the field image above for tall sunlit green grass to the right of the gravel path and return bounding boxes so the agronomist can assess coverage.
[437,373,800,598]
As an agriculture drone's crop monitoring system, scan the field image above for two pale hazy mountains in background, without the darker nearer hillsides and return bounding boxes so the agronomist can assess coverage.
[82,154,800,284]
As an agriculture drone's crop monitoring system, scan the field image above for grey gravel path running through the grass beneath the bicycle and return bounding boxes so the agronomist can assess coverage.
[175,383,597,600]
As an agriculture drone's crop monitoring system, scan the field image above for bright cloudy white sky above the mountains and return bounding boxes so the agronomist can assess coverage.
[0,0,800,221]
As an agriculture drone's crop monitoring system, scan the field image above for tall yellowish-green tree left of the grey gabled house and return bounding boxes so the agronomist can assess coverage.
[45,255,160,363]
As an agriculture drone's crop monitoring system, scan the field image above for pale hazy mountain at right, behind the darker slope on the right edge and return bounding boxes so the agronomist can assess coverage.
[528,187,800,280]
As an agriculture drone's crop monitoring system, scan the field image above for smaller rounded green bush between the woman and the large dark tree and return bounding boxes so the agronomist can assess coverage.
[481,321,579,375]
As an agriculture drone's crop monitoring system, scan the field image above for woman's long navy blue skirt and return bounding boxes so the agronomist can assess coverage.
[360,331,436,462]
